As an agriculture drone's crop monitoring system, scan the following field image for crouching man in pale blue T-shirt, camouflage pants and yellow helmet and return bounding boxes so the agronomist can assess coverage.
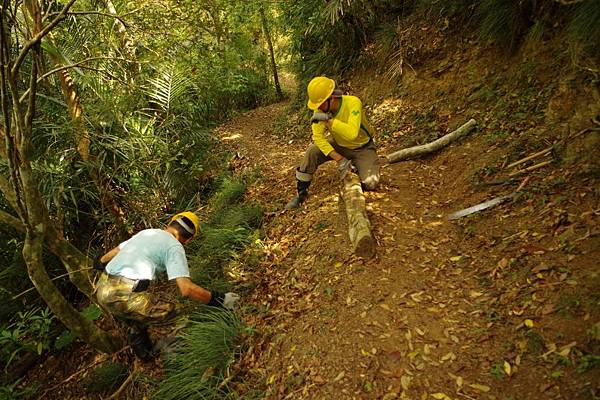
[96,211,239,361]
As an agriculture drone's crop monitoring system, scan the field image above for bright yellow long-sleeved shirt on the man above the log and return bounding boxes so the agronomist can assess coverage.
[312,96,372,155]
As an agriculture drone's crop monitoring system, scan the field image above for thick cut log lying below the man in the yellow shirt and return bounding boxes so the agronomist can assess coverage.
[340,173,375,258]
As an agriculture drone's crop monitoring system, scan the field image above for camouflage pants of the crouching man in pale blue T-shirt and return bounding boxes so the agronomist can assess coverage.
[96,273,177,325]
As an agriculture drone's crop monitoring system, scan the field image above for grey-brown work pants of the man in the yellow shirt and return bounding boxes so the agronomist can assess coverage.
[296,138,380,190]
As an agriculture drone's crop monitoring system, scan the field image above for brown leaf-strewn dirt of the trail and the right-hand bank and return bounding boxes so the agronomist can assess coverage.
[218,42,600,400]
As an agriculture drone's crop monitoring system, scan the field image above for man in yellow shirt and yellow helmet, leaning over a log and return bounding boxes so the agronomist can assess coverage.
[285,76,380,209]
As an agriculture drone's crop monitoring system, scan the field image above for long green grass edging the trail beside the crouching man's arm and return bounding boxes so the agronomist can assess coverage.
[152,177,262,400]
